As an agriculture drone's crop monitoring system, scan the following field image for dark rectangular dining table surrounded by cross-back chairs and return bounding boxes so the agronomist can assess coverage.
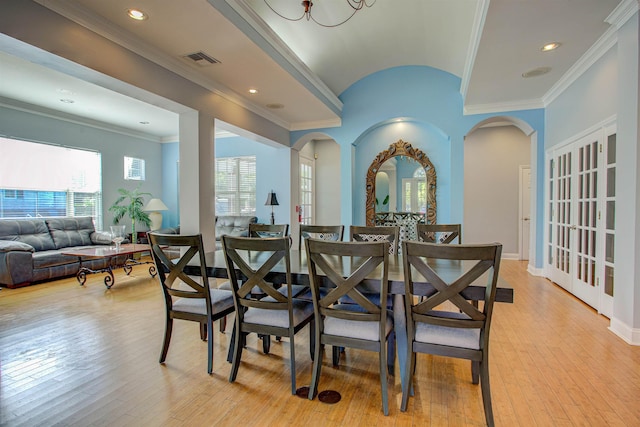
[185,249,514,392]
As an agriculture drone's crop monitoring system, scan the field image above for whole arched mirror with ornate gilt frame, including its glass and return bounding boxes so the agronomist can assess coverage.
[366,140,436,226]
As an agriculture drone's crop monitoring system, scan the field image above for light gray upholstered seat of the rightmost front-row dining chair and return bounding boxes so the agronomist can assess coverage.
[415,311,480,350]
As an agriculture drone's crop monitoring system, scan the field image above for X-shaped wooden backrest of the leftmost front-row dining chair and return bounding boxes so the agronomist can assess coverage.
[147,232,211,310]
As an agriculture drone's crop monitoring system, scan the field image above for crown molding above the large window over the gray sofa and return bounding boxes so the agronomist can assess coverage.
[0,96,165,143]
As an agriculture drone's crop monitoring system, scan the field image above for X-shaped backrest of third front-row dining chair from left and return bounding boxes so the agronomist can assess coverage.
[305,238,389,330]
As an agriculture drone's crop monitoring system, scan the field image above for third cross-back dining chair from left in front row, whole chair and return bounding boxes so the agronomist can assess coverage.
[305,239,393,415]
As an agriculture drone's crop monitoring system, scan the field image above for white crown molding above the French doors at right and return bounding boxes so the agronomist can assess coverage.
[542,26,618,107]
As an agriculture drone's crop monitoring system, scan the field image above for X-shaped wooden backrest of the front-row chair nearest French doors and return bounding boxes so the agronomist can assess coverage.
[402,241,502,348]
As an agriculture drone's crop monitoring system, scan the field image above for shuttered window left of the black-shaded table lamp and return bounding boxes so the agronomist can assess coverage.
[216,156,256,215]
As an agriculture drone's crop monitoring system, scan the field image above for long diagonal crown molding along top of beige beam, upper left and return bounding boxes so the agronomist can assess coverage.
[34,0,291,130]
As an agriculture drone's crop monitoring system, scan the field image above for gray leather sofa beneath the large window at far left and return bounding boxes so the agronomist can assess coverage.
[0,217,122,288]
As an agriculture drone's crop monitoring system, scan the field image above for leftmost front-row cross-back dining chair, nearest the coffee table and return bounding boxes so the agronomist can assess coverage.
[147,232,234,374]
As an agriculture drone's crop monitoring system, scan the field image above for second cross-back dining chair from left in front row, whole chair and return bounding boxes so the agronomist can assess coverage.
[222,236,315,394]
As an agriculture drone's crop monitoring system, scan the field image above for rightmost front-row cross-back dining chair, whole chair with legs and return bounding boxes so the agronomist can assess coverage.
[400,241,502,426]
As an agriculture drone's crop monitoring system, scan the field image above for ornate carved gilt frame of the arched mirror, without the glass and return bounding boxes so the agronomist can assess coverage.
[365,139,436,226]
